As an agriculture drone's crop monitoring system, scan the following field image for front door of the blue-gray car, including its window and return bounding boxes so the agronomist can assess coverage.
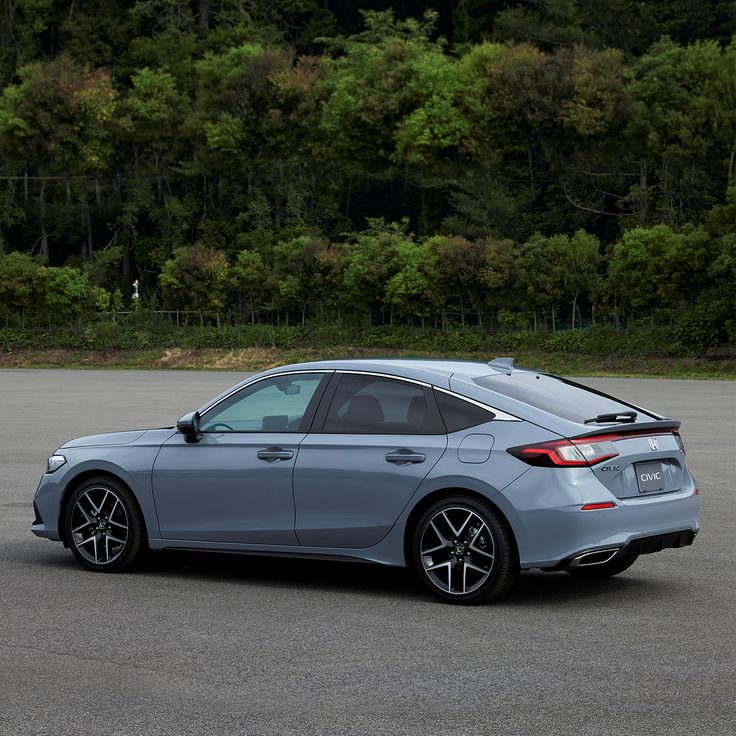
[153,372,326,544]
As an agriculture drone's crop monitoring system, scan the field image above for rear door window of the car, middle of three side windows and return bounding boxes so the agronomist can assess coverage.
[324,374,444,434]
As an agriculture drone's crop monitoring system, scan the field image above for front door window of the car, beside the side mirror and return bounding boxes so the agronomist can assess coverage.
[201,373,326,432]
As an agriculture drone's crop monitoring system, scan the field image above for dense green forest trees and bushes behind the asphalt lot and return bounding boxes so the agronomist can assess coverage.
[0,0,736,347]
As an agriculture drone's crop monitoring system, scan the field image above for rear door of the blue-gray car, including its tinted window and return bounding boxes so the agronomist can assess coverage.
[294,373,447,548]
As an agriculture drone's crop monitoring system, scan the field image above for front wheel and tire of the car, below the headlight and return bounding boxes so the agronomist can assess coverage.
[64,476,147,572]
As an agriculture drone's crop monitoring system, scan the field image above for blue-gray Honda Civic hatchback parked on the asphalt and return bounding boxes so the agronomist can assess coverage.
[32,358,699,604]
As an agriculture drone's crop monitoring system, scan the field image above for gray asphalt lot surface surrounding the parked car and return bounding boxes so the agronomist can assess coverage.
[0,370,736,736]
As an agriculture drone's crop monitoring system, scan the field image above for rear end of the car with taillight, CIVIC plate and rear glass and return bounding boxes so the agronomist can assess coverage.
[452,370,699,569]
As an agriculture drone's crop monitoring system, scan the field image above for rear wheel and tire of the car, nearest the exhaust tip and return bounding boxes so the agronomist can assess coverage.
[411,495,519,605]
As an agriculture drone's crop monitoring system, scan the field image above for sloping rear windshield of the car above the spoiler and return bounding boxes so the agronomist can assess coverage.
[473,371,657,424]
